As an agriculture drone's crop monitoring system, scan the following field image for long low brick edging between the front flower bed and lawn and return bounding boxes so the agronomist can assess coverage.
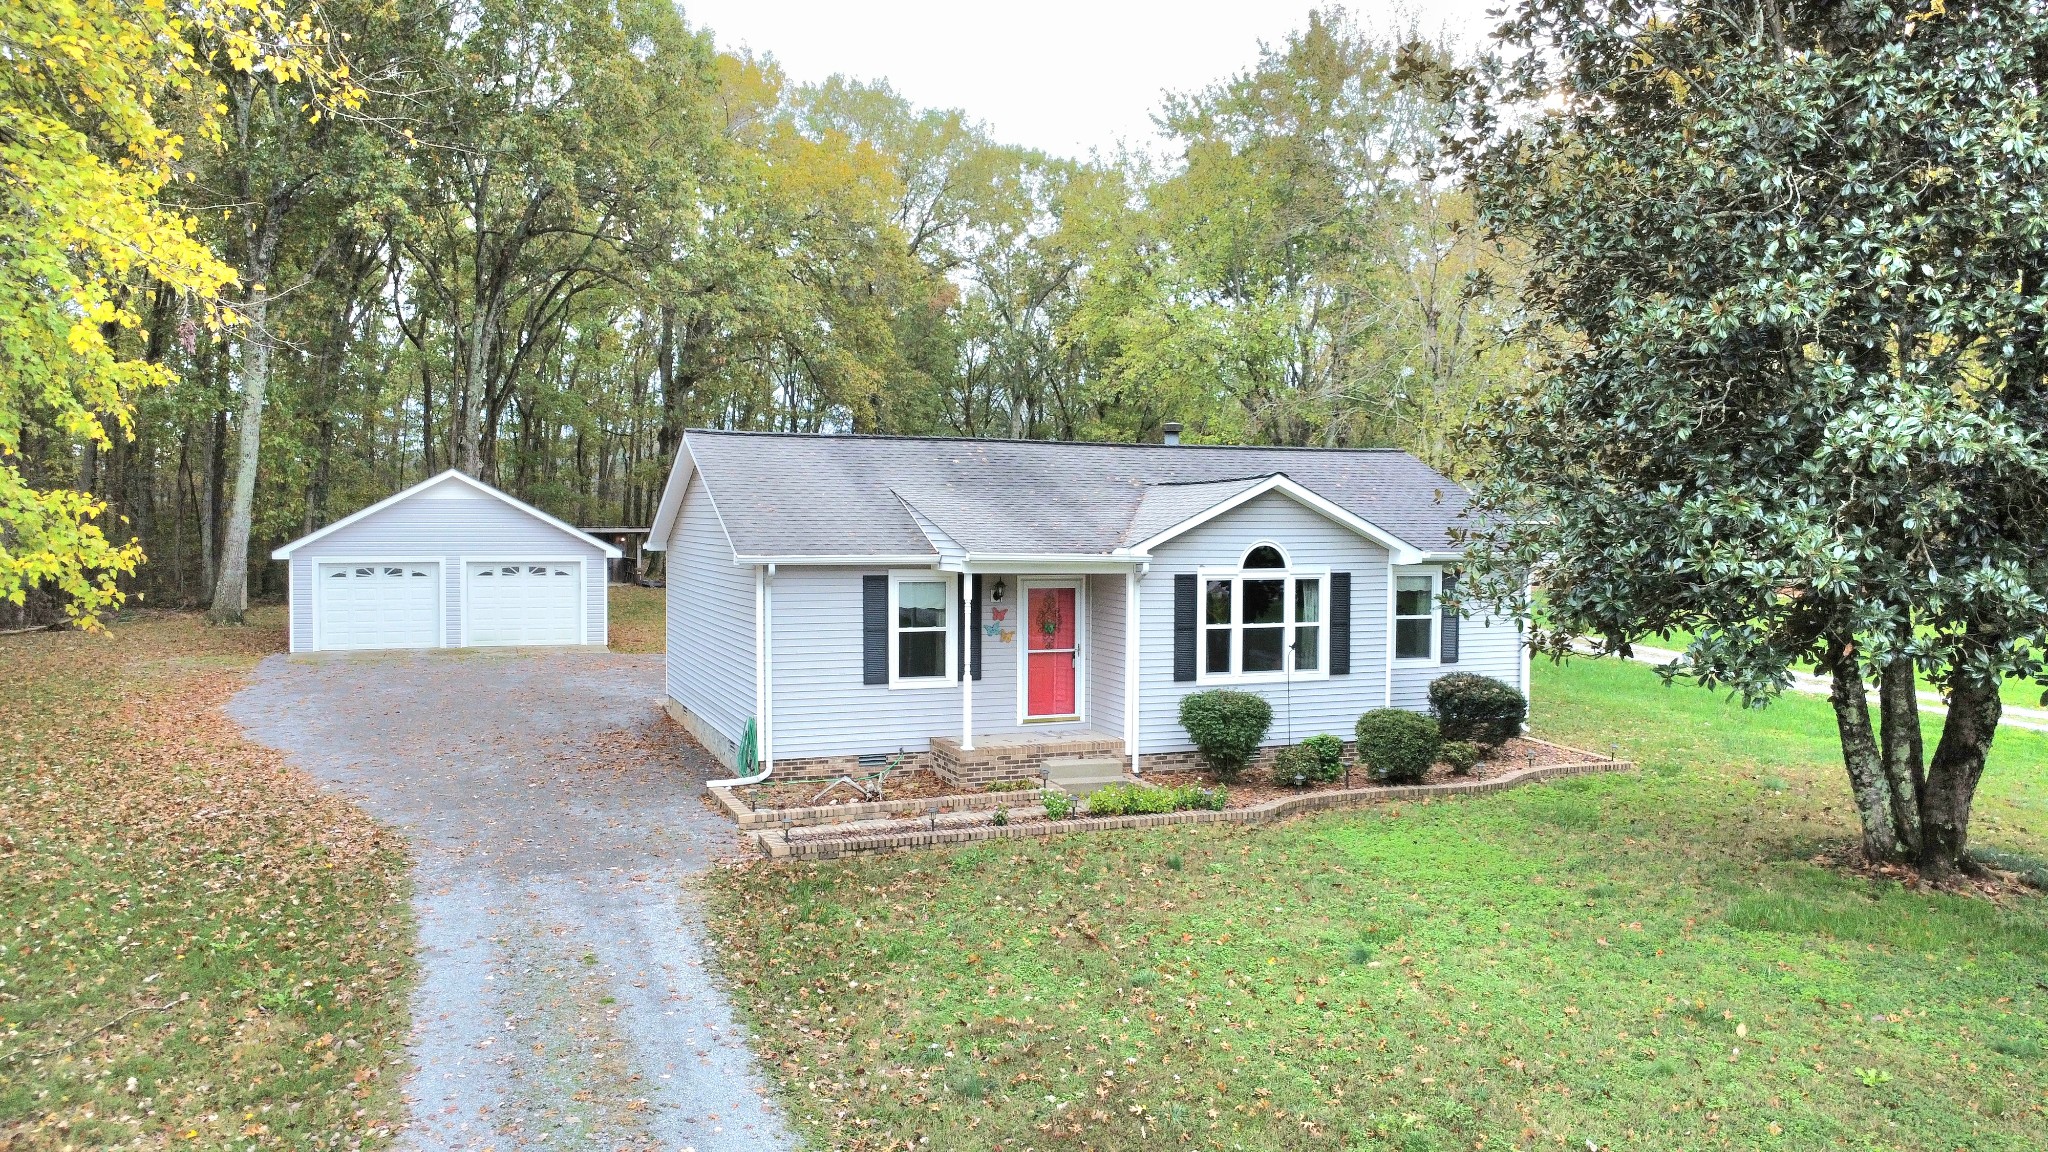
[754,744,1636,861]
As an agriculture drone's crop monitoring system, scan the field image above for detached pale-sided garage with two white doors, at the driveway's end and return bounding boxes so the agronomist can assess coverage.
[270,471,618,652]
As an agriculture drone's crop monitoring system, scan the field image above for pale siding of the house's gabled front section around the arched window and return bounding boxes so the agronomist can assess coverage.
[1139,492,1386,752]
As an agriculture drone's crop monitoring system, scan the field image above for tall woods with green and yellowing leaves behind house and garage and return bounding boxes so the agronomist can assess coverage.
[8,0,1518,617]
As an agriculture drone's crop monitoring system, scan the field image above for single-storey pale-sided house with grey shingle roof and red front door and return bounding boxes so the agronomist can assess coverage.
[647,430,1528,781]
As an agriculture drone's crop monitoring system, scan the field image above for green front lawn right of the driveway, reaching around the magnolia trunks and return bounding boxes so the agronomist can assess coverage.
[711,662,2048,1152]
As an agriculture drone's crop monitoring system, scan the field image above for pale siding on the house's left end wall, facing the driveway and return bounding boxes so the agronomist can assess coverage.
[666,478,757,756]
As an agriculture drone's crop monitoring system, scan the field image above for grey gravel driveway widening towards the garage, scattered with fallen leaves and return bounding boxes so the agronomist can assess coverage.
[229,652,795,1152]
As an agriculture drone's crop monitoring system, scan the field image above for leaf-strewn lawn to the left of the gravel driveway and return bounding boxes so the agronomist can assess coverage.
[0,607,412,1150]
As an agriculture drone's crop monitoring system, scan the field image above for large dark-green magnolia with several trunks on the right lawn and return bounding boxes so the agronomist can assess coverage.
[1462,0,2048,877]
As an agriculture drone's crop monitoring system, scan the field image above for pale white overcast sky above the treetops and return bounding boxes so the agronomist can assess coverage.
[682,0,1501,158]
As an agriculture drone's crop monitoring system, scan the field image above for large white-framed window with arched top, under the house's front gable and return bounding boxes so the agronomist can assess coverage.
[1198,543,1329,681]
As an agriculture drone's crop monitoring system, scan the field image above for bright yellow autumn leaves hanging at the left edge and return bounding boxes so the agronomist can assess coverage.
[0,0,360,625]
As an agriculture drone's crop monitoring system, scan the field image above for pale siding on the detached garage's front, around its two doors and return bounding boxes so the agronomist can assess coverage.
[287,471,608,652]
